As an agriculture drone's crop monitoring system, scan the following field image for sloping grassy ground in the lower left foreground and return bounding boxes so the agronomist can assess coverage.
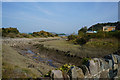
[2,44,52,78]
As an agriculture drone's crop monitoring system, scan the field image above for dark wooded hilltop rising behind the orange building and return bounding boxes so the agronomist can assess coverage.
[88,22,120,31]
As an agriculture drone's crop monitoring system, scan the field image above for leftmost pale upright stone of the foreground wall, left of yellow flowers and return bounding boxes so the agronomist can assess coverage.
[51,70,63,80]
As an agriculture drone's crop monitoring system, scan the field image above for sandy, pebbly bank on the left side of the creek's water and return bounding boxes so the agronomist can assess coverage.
[2,38,62,78]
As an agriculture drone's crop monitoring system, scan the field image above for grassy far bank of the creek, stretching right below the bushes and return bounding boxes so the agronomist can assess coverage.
[41,38,119,57]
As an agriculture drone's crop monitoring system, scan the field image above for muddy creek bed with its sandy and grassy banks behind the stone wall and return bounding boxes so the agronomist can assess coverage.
[3,37,120,78]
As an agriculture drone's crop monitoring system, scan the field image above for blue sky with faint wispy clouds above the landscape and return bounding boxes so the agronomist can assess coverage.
[2,2,118,34]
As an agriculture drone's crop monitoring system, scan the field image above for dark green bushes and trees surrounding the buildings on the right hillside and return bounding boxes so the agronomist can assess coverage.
[68,22,120,45]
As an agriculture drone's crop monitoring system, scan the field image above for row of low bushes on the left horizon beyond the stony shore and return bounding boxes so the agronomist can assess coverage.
[2,27,57,38]
